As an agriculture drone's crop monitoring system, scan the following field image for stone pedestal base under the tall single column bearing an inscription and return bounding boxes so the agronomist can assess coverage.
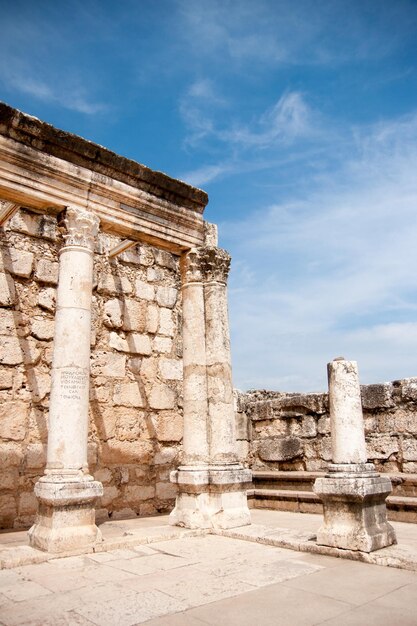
[28,476,103,554]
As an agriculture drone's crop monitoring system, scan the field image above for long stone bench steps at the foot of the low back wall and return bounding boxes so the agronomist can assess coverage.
[248,471,417,523]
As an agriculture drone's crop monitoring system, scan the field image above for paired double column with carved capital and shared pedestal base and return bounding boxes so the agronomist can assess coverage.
[170,227,251,528]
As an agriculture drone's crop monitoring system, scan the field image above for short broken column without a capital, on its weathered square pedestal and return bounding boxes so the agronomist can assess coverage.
[314,358,396,552]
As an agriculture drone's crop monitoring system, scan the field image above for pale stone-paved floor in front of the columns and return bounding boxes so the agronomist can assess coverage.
[0,511,417,626]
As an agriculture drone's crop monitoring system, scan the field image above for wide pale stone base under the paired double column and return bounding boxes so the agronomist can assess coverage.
[169,465,252,529]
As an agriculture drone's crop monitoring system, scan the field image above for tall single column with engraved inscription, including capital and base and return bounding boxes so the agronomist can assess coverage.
[29,208,103,553]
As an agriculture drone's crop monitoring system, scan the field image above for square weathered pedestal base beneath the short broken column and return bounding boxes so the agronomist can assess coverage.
[313,464,397,552]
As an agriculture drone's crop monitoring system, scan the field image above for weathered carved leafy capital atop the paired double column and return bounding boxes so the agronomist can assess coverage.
[182,246,230,284]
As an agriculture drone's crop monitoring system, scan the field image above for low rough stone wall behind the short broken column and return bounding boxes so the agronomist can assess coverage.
[237,378,417,473]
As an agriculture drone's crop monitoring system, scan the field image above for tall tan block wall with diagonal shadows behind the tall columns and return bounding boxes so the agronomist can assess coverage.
[0,210,182,528]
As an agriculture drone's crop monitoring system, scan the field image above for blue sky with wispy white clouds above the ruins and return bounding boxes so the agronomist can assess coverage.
[0,0,417,391]
